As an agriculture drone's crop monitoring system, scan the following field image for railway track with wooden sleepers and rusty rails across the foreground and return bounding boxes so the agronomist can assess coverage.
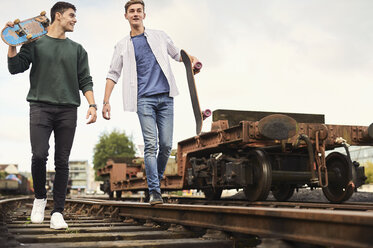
[0,197,373,247]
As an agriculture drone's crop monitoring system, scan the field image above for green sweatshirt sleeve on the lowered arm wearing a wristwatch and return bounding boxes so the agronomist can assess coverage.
[78,46,93,94]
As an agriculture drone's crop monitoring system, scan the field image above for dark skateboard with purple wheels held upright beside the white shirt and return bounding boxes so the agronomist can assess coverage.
[181,50,211,135]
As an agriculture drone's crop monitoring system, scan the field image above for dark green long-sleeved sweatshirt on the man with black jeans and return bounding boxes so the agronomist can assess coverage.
[8,35,93,106]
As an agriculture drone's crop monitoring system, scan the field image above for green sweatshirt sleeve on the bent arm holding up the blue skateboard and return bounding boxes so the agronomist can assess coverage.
[8,43,32,74]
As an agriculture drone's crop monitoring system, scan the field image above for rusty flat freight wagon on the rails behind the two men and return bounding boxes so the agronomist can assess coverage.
[98,110,373,203]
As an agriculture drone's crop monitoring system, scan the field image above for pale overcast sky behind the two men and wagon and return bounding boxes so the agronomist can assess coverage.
[0,0,373,171]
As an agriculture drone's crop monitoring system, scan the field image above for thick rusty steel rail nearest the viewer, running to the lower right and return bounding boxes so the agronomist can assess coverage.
[67,200,373,248]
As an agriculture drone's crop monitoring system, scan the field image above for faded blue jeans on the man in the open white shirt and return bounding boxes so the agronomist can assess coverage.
[137,93,174,193]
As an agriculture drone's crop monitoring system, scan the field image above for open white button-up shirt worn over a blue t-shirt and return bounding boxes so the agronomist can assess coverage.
[107,29,180,112]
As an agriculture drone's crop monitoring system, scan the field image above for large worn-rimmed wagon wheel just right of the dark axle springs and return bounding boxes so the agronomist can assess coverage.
[243,150,272,201]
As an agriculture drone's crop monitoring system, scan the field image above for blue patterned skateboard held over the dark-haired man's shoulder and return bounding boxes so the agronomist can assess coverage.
[1,11,49,46]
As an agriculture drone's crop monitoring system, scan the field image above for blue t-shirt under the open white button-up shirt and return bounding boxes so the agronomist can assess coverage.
[132,34,170,97]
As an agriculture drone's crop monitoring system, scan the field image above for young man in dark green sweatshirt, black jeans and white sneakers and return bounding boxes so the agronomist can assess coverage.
[6,2,97,229]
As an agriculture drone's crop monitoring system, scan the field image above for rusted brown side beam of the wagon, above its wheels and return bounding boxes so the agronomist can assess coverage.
[178,118,373,156]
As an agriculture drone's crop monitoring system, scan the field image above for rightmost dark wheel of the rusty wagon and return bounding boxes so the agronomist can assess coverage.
[322,152,354,203]
